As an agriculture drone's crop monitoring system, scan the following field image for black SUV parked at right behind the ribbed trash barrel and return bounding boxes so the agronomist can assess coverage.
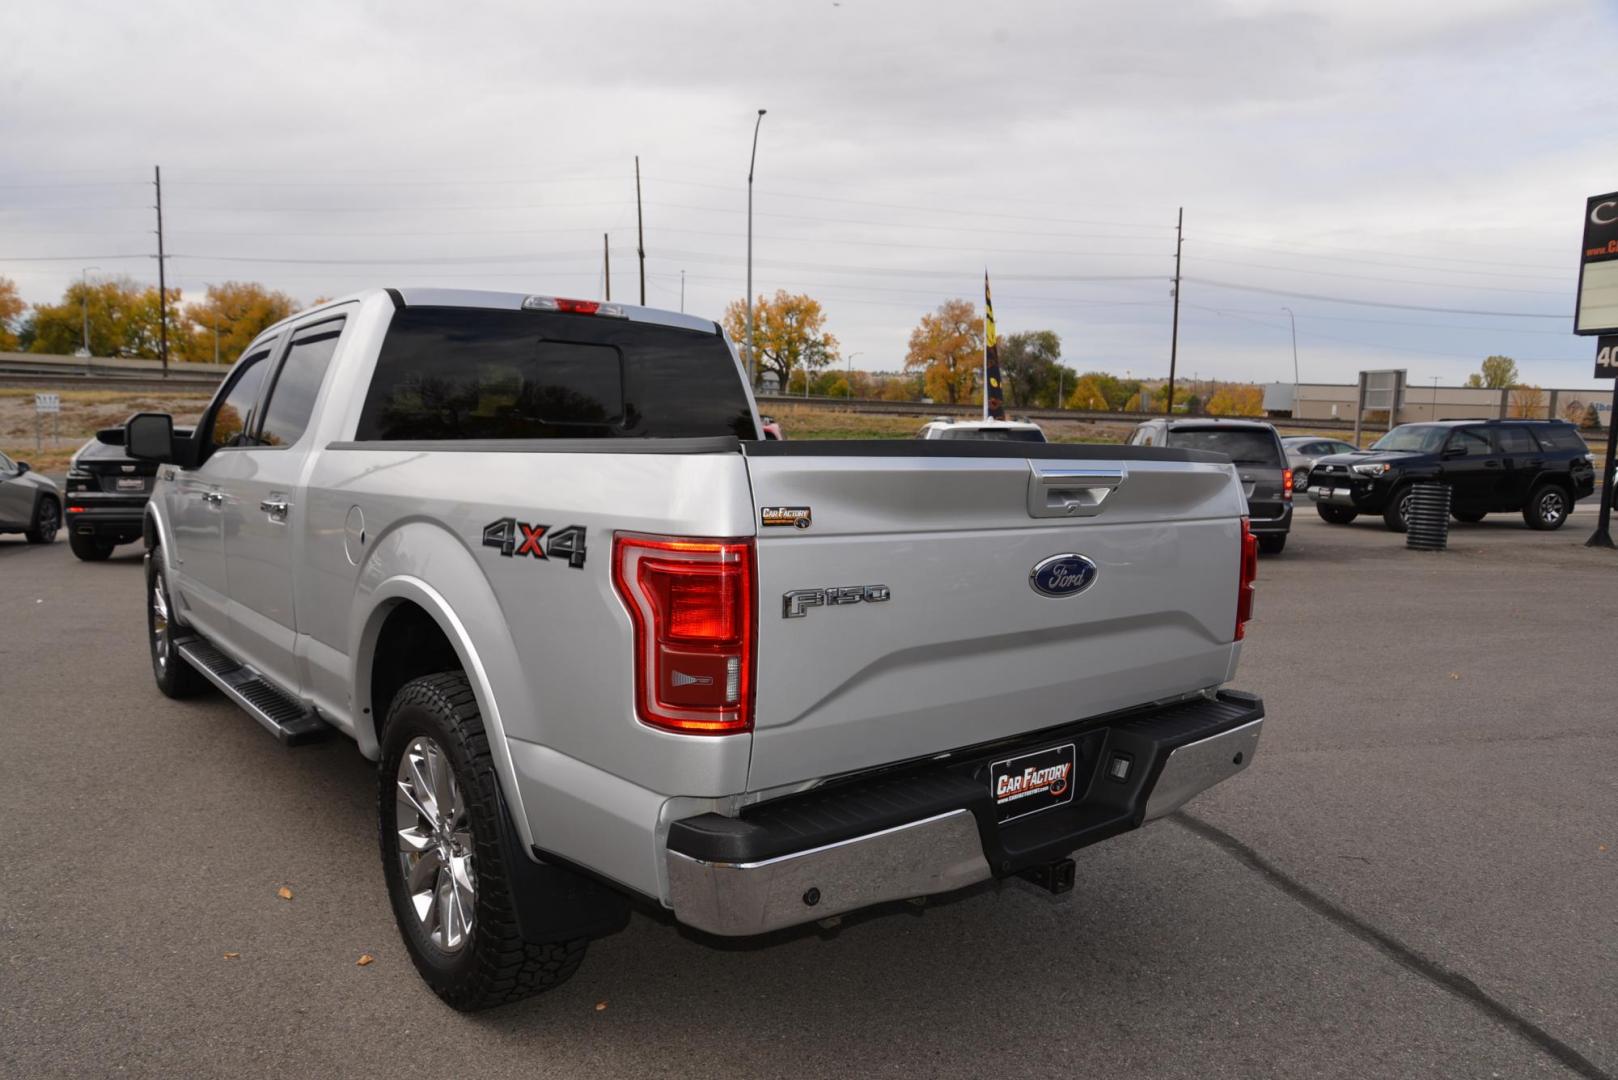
[1309,419,1595,533]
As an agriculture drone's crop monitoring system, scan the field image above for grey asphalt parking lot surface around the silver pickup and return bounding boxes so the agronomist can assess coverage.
[0,505,1618,1078]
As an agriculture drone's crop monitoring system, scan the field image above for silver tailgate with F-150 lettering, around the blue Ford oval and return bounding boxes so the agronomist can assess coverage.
[748,442,1243,790]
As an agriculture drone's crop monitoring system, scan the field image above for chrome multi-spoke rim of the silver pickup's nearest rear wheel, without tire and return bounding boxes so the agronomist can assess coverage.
[393,735,477,952]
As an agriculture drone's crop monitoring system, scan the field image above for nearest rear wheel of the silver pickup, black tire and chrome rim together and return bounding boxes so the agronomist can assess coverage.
[377,672,589,1012]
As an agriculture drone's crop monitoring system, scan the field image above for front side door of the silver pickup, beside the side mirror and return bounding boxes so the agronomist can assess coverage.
[159,342,275,641]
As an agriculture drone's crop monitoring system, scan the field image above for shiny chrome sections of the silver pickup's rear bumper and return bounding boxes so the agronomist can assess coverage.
[667,719,1264,938]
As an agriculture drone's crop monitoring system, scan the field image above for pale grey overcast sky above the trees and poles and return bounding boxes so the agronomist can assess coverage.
[0,0,1618,387]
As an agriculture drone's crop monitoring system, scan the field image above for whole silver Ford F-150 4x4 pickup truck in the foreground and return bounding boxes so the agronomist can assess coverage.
[122,290,1264,1009]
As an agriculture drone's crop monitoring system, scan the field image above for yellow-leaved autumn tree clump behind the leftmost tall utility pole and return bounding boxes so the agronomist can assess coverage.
[23,277,180,359]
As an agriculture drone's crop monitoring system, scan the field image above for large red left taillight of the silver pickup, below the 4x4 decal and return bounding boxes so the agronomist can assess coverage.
[612,533,754,735]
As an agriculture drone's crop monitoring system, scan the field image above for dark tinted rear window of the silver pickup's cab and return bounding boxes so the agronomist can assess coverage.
[354,308,757,440]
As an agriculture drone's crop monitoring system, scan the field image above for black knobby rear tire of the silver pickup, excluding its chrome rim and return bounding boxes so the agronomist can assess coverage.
[377,672,589,1012]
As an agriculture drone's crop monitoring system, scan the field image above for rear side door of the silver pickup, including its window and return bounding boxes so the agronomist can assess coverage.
[218,316,343,693]
